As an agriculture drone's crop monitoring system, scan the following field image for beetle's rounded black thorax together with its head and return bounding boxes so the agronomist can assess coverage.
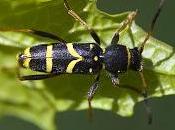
[103,44,142,74]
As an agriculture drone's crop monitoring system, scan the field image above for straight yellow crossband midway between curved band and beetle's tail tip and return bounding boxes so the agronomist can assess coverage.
[46,45,53,73]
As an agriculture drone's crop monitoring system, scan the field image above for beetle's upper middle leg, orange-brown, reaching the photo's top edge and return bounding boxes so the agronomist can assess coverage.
[64,0,100,45]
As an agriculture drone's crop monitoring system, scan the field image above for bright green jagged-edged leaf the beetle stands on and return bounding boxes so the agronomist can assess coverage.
[0,0,175,130]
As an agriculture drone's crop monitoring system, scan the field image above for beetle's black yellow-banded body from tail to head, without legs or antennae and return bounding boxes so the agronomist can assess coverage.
[18,42,142,75]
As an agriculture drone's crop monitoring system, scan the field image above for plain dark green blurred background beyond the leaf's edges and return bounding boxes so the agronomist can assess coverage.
[0,0,175,130]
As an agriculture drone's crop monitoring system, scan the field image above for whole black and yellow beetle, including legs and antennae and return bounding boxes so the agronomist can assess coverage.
[13,0,164,122]
